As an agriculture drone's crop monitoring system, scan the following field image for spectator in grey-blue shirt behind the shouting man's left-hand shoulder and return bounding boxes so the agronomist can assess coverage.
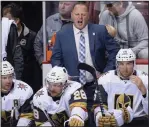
[34,1,76,66]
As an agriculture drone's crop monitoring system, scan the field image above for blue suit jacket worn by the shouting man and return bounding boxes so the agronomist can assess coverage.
[51,24,120,76]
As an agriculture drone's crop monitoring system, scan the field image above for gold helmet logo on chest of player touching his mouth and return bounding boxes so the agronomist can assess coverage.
[114,94,133,109]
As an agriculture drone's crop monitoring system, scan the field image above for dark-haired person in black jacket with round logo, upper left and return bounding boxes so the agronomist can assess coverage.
[3,3,42,92]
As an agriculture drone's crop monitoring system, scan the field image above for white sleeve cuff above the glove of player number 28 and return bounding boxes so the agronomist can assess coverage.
[71,107,88,121]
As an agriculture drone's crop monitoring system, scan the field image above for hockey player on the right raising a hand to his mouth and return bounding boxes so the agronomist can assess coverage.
[94,49,148,127]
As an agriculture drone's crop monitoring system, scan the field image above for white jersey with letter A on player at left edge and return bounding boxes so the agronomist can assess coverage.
[1,80,33,126]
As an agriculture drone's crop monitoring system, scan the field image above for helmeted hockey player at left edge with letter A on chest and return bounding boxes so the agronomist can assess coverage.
[0,61,33,127]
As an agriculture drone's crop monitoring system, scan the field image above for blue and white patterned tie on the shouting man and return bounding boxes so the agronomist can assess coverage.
[79,31,86,84]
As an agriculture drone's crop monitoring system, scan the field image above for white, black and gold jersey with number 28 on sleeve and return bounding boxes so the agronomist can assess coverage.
[33,81,88,127]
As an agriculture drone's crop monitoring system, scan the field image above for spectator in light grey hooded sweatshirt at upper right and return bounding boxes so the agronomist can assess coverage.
[99,1,148,59]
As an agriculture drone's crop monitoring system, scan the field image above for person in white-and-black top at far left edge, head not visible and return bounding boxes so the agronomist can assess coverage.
[2,16,24,79]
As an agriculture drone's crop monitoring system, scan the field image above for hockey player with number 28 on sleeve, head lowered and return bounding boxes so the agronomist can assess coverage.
[33,66,88,127]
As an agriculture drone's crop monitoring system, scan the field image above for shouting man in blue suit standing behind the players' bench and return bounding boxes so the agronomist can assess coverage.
[51,2,120,126]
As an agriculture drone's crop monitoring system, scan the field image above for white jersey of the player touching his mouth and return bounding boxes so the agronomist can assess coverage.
[98,70,148,118]
